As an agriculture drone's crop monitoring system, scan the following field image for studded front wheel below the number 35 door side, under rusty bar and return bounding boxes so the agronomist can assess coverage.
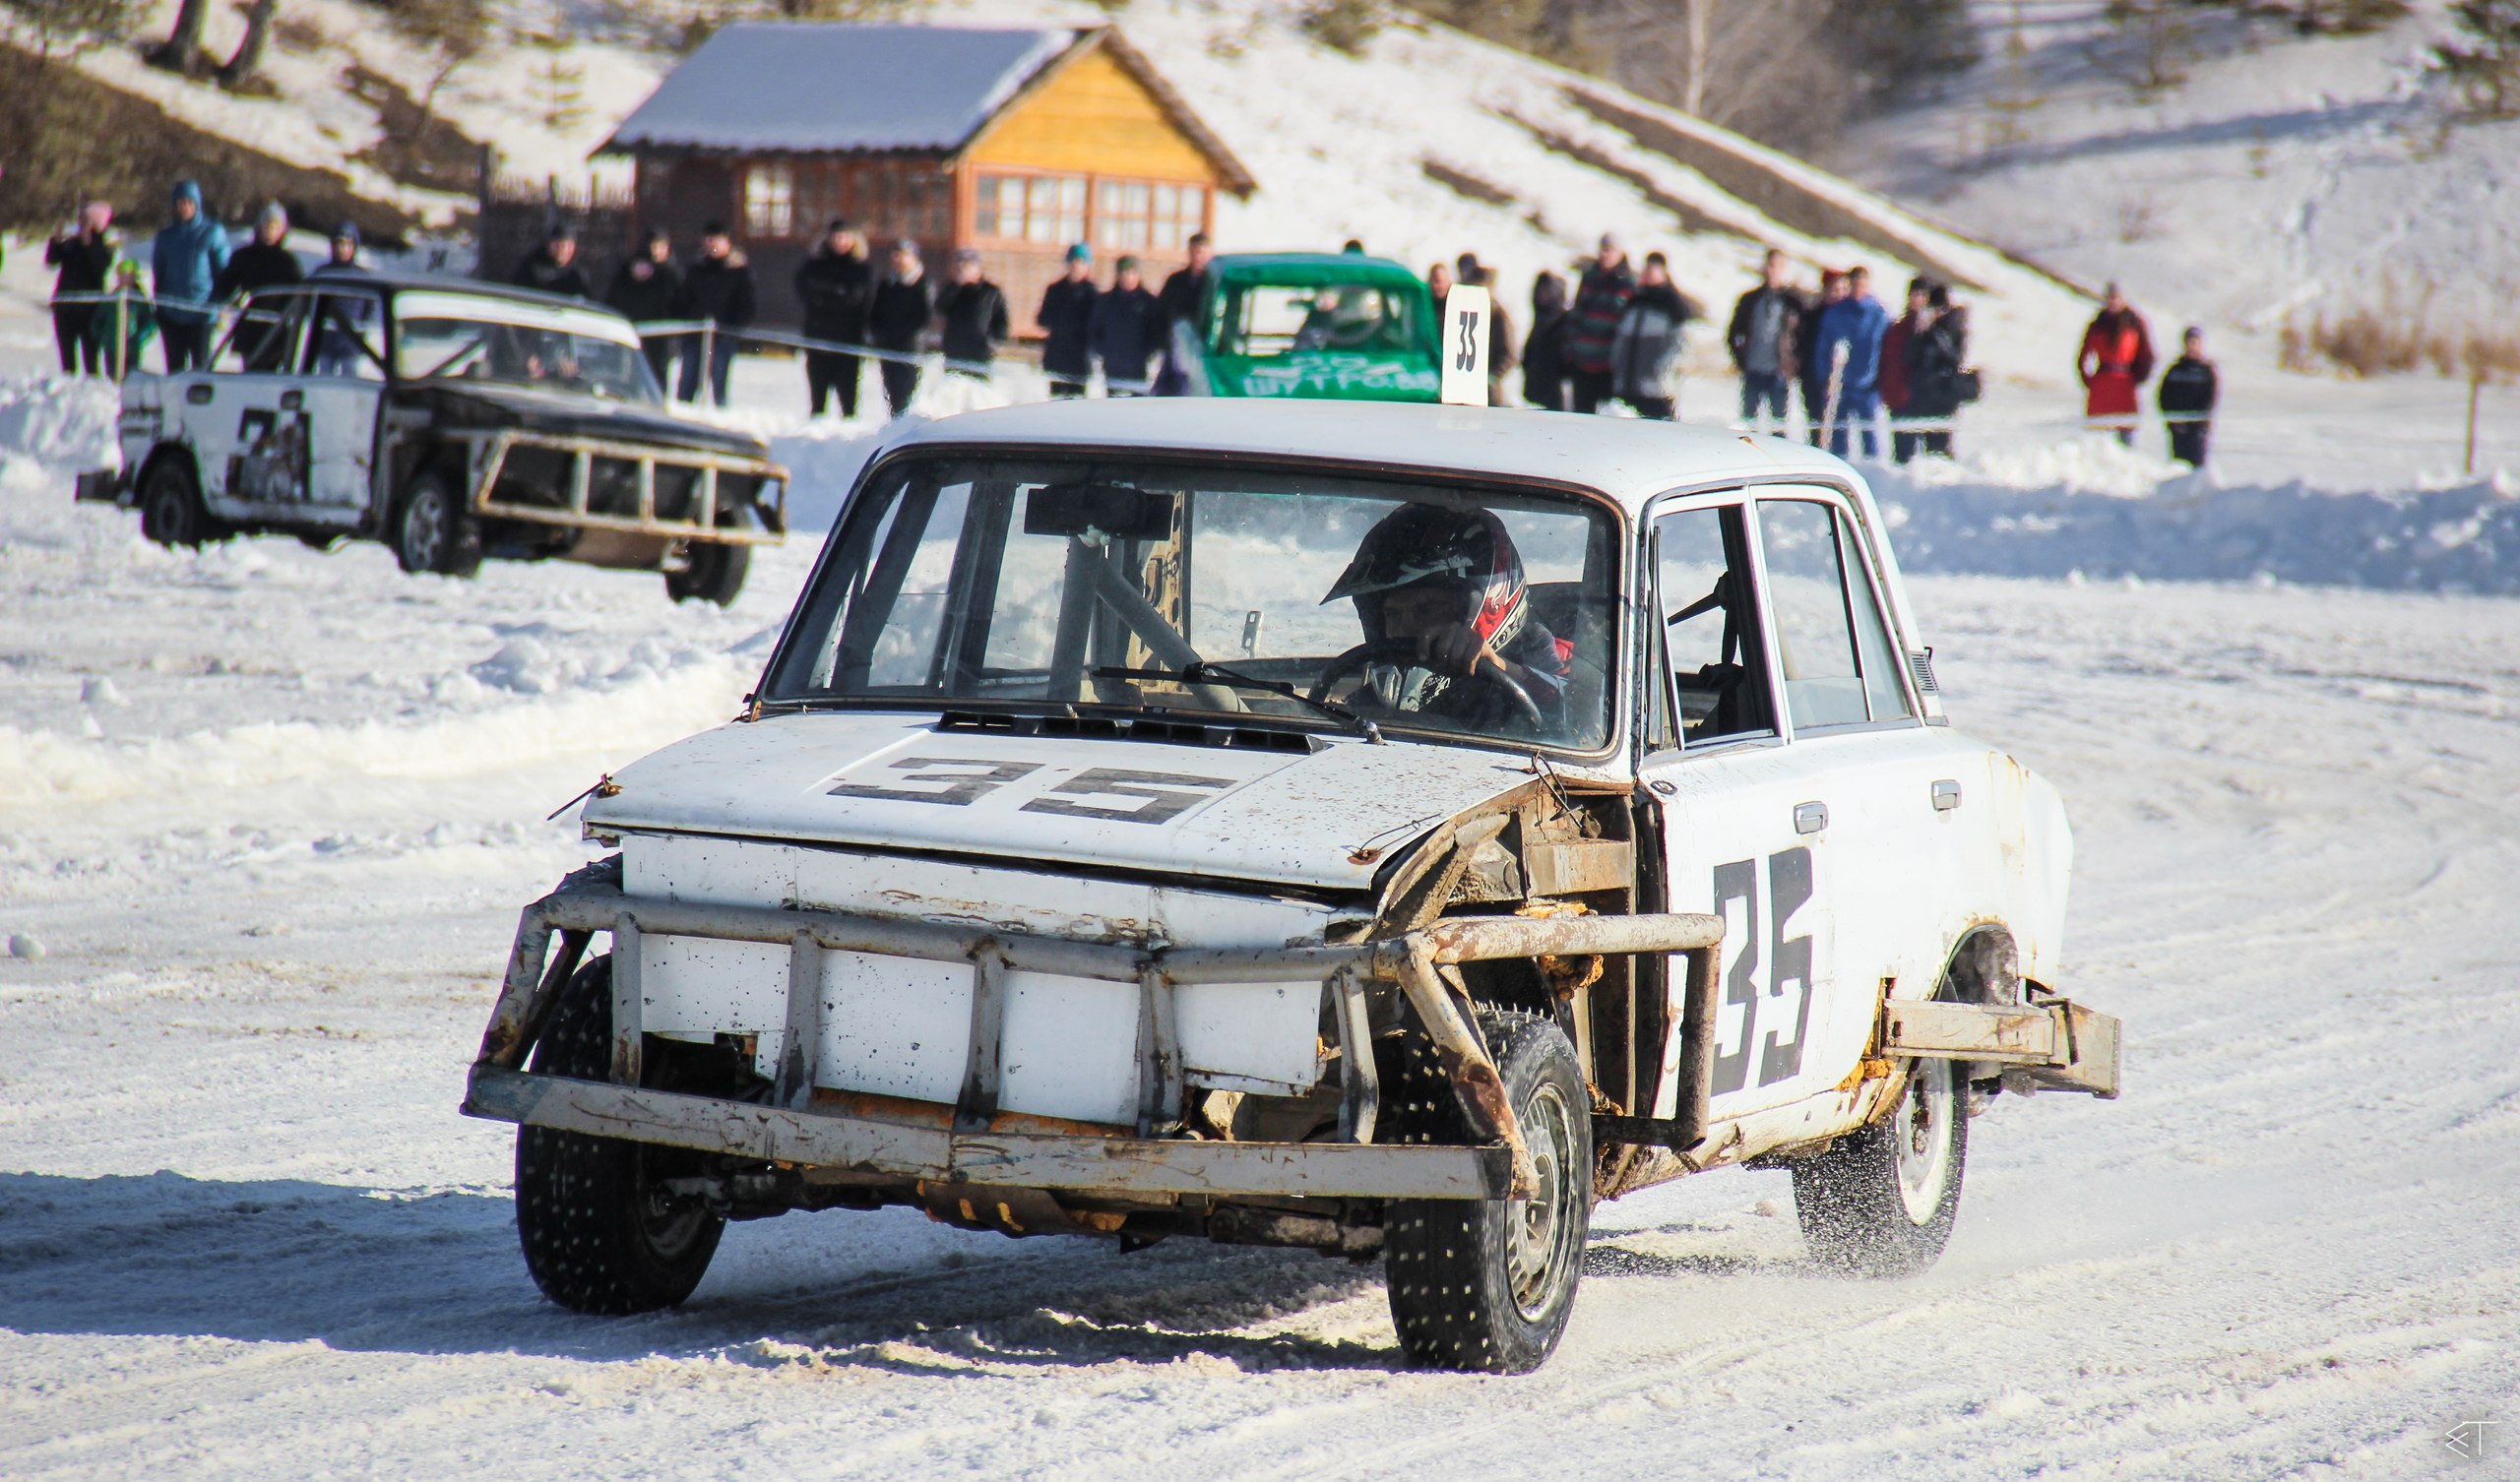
[1381,1014,1593,1374]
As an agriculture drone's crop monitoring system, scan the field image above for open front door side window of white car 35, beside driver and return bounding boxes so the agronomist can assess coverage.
[1653,504,1777,746]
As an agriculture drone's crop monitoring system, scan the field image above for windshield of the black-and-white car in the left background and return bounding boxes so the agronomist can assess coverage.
[393,292,662,403]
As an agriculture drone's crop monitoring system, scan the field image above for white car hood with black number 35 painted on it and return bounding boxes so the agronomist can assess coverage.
[585,710,1532,890]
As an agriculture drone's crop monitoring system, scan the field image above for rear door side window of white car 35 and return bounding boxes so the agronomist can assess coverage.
[1759,499,1910,728]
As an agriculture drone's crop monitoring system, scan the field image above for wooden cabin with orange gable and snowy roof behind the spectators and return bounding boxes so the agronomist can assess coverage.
[599,20,1252,336]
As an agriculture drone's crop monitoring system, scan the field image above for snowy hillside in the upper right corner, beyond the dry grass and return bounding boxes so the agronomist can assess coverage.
[1842,0,2520,331]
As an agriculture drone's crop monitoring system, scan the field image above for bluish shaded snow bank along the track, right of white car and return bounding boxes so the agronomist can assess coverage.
[1872,444,2520,594]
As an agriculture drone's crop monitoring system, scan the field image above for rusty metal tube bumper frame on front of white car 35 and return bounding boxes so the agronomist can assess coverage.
[464,867,1724,1200]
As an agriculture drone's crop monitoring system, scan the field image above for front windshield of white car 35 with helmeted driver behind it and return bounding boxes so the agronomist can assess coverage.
[764,454,1618,751]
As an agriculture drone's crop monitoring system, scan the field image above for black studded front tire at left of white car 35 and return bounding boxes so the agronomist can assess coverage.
[517,956,725,1316]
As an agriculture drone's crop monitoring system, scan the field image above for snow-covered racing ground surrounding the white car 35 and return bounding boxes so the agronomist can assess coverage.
[0,292,2520,1482]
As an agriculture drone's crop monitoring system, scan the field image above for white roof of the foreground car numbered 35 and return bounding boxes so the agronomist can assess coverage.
[890,396,1870,514]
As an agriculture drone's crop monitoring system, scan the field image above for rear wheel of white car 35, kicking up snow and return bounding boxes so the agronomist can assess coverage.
[1795,1061,1968,1278]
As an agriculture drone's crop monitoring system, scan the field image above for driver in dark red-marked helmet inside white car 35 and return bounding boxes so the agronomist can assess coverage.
[1323,504,1575,733]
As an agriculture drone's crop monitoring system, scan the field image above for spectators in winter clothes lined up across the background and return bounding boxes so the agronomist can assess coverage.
[45,181,2220,463]
